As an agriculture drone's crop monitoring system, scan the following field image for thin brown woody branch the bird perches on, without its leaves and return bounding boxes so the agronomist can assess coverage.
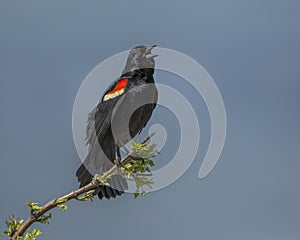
[10,133,154,240]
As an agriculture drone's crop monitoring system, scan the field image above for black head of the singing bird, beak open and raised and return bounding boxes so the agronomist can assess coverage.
[123,45,158,74]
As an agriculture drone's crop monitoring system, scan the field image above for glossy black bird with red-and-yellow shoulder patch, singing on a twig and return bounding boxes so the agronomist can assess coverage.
[76,45,157,199]
